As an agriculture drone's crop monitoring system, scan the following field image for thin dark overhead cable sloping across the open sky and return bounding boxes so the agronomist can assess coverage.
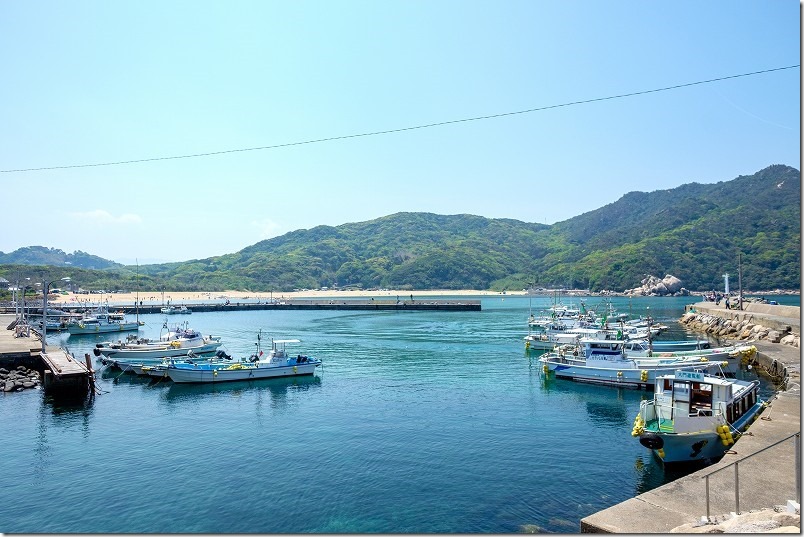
[0,64,800,173]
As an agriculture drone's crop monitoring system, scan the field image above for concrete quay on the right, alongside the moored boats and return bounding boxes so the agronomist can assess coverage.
[580,303,801,533]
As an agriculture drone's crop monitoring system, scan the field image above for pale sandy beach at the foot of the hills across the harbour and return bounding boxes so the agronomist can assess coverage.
[48,289,526,305]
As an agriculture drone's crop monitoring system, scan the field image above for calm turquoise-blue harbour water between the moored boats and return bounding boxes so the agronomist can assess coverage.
[0,296,798,533]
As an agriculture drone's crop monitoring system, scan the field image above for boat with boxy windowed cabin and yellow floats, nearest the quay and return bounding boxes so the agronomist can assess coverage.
[631,371,766,464]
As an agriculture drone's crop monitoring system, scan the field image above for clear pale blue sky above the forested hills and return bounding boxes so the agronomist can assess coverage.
[0,0,801,264]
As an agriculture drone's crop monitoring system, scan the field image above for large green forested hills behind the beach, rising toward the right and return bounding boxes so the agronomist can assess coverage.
[0,165,801,291]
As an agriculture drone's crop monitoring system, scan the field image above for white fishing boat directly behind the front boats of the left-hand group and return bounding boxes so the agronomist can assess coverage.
[92,322,221,365]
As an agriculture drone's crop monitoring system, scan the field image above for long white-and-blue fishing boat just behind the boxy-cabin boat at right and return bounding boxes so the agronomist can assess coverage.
[539,340,729,390]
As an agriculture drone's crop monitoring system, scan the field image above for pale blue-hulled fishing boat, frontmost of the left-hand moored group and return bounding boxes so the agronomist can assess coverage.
[167,336,321,383]
